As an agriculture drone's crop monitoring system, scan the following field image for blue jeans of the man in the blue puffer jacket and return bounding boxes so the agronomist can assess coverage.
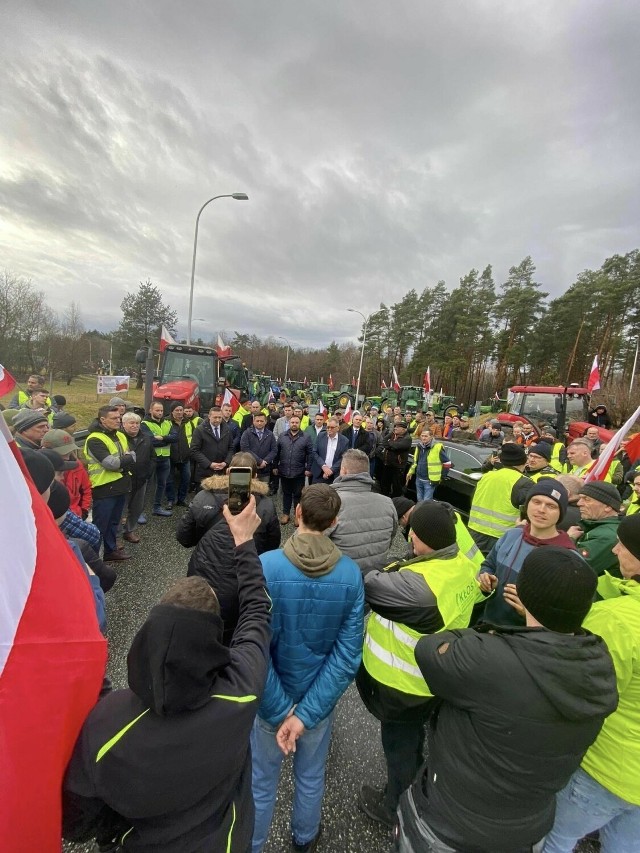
[251,711,334,853]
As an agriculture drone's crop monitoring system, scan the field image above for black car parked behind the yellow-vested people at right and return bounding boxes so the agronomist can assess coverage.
[405,437,496,520]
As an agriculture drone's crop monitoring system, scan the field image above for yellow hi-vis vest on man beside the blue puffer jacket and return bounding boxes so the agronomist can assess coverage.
[362,551,483,697]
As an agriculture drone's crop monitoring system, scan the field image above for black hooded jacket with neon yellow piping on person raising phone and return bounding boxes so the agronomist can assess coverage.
[63,542,270,853]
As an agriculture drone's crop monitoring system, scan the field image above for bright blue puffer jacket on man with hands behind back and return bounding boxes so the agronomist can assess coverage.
[258,550,364,729]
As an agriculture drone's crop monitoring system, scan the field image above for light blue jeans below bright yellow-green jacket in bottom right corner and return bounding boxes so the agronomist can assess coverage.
[544,767,640,853]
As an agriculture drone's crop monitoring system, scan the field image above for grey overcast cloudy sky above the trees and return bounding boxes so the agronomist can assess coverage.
[0,0,640,346]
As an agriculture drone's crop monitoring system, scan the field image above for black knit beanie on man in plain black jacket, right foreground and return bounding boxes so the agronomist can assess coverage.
[517,545,598,634]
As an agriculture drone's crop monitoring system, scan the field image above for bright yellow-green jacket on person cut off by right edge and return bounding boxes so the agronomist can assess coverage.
[582,573,640,806]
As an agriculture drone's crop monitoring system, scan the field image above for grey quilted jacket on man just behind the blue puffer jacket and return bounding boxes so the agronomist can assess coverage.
[326,474,398,574]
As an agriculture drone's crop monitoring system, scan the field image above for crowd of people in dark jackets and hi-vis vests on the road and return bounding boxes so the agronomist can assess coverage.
[2,377,640,853]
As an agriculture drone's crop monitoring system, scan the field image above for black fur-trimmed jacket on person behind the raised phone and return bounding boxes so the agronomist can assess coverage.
[176,476,281,646]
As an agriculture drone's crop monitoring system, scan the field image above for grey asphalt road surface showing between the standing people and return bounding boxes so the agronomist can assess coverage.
[64,492,599,853]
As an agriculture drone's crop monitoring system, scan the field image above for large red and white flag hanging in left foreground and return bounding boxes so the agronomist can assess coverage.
[0,418,107,853]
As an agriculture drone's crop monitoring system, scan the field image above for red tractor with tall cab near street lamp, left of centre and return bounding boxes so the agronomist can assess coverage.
[153,344,248,415]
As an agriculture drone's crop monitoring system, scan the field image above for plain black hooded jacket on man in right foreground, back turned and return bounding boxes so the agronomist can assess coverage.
[412,628,617,853]
